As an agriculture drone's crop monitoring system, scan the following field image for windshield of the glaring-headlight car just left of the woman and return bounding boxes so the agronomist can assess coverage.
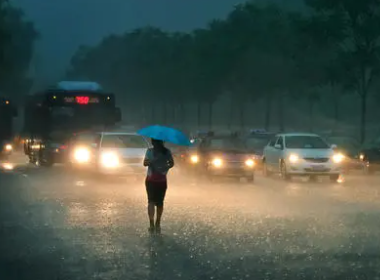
[101,134,147,149]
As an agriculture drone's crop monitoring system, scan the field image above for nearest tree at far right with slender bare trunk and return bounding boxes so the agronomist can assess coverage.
[307,0,380,142]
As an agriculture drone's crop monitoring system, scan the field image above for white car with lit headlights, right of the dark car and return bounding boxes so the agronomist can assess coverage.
[263,133,344,181]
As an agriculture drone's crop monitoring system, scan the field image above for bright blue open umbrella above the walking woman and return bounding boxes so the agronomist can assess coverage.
[137,125,191,146]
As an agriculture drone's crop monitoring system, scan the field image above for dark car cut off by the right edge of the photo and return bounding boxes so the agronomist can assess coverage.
[359,139,380,174]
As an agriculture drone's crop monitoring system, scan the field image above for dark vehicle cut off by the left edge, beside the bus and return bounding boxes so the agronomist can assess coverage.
[0,97,17,157]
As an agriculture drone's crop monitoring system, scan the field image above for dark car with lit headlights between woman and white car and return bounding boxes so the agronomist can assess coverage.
[186,135,255,182]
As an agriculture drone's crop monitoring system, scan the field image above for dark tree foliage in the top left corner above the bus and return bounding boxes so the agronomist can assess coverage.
[0,0,38,101]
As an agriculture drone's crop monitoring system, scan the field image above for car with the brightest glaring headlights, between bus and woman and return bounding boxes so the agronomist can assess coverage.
[69,131,150,176]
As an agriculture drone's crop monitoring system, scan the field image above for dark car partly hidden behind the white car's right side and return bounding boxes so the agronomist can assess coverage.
[326,135,364,171]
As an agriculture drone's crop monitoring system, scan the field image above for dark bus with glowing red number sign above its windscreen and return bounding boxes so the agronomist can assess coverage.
[24,81,121,167]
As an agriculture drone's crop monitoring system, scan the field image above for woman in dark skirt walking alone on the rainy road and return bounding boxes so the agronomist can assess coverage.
[144,139,174,233]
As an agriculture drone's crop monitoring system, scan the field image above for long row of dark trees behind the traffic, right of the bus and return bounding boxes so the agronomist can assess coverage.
[67,0,380,142]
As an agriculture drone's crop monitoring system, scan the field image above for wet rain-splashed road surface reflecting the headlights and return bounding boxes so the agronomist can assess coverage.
[0,155,380,280]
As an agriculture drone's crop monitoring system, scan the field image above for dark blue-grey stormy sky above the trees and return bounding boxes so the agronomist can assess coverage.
[14,0,244,83]
